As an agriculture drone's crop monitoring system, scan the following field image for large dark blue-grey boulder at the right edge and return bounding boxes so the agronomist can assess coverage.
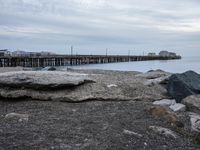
[167,71,200,102]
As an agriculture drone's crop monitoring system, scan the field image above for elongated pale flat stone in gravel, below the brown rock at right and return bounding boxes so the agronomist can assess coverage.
[149,126,178,139]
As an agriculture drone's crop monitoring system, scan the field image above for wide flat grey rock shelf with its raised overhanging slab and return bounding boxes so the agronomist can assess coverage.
[0,71,168,102]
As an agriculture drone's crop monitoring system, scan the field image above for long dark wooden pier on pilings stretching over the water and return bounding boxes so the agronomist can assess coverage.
[0,55,181,67]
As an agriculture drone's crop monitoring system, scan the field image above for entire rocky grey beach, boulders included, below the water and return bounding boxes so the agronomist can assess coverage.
[0,68,200,150]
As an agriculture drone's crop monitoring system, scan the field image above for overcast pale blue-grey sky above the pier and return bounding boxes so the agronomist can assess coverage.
[0,0,200,55]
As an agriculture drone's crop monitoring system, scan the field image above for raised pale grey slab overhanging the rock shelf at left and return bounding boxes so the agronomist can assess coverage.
[0,71,93,90]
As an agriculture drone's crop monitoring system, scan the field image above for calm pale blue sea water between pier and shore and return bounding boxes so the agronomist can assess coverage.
[70,57,200,73]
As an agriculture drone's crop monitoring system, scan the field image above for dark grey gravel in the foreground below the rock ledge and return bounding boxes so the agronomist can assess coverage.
[0,101,200,150]
